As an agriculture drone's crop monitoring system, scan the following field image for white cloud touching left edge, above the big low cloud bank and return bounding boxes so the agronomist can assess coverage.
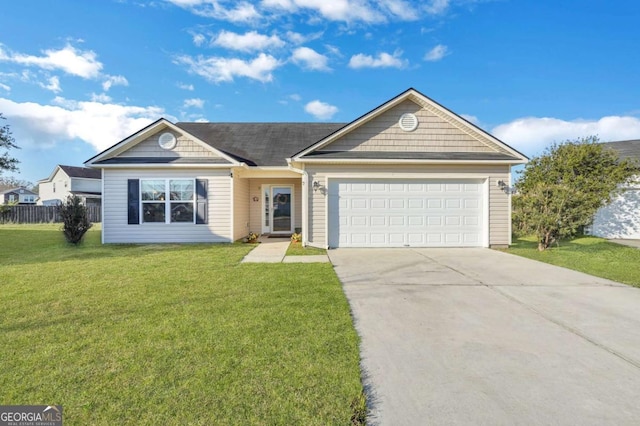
[0,44,102,79]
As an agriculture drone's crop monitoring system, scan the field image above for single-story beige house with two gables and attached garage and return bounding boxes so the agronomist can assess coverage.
[85,89,527,248]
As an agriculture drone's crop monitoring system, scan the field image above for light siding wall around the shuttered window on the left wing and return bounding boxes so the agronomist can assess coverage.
[102,169,232,243]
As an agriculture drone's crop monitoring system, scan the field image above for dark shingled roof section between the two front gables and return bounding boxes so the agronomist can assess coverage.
[176,123,346,166]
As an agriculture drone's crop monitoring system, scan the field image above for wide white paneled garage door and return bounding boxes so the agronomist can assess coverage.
[329,179,485,247]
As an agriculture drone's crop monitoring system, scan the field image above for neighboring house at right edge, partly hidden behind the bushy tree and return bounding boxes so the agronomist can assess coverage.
[587,140,640,239]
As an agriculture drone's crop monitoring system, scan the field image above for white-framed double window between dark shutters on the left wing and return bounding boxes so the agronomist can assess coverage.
[140,179,196,223]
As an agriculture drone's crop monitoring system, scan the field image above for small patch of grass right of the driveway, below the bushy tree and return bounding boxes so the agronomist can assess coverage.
[505,237,640,287]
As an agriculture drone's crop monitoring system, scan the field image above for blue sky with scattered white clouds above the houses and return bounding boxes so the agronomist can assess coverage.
[0,0,640,182]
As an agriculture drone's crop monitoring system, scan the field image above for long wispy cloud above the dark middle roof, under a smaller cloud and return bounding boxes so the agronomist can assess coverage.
[175,53,282,83]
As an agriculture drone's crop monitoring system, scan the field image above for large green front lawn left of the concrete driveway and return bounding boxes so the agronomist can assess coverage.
[0,225,362,425]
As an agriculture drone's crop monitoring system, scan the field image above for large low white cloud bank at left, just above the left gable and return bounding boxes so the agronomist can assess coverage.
[0,98,165,151]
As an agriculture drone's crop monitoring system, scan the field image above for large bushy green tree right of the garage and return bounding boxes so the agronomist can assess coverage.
[513,136,638,251]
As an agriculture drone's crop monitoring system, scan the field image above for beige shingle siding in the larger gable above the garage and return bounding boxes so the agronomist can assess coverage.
[320,100,504,152]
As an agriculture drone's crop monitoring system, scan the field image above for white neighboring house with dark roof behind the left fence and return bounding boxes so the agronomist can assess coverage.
[38,165,102,206]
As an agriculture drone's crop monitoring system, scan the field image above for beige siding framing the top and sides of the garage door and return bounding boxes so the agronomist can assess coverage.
[306,165,511,247]
